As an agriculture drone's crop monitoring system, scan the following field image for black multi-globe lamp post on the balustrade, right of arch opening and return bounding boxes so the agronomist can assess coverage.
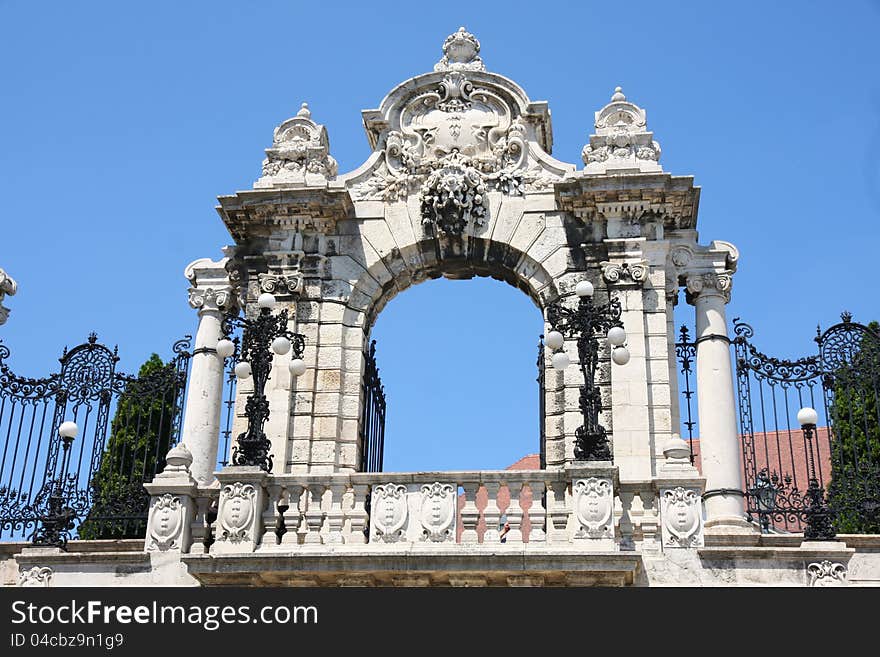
[545,281,629,461]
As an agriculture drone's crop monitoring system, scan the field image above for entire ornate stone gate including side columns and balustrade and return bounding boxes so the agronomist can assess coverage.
[5,28,872,585]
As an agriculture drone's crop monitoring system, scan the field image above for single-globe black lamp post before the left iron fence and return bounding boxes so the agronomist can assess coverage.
[31,421,79,550]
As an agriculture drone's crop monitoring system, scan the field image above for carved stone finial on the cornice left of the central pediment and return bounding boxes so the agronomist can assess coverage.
[254,103,338,189]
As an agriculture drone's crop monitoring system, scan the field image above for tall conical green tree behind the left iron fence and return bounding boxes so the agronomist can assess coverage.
[79,354,178,539]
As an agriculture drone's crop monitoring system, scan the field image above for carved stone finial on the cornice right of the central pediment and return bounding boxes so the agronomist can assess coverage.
[581,87,663,173]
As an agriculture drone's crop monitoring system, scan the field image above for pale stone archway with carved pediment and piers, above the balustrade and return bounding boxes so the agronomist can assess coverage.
[194,28,738,532]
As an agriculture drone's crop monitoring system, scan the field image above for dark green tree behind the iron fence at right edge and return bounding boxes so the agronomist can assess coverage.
[828,322,880,534]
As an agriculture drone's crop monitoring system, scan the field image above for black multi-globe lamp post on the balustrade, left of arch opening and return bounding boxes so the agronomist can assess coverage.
[217,293,306,472]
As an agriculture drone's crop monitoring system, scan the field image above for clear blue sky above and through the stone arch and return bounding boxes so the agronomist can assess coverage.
[0,0,880,469]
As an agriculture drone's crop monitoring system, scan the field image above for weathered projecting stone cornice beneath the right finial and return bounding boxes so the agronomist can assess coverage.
[555,173,700,230]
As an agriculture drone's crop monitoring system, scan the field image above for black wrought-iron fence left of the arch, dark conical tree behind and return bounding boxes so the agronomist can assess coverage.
[0,333,191,546]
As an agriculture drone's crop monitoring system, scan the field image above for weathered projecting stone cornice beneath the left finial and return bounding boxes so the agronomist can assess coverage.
[217,187,354,243]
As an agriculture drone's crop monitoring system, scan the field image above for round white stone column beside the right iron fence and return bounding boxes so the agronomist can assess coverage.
[687,271,751,533]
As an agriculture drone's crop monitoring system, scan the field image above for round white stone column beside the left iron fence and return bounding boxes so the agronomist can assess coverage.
[182,258,237,486]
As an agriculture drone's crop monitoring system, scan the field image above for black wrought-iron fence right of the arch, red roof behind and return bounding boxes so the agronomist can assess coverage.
[733,313,880,533]
